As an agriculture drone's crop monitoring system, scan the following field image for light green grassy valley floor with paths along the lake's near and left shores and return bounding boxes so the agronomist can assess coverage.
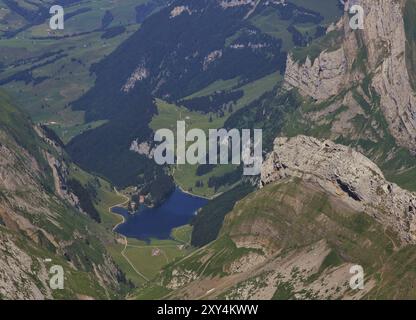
[70,162,197,287]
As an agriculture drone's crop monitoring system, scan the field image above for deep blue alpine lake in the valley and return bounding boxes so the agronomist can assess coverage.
[112,189,208,240]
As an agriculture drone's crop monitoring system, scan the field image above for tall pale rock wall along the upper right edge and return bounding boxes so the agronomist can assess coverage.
[363,0,416,150]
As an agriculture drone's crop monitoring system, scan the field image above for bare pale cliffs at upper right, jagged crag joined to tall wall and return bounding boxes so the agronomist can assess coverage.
[285,0,416,150]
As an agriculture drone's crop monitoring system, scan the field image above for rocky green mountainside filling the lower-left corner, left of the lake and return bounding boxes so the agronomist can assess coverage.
[0,93,125,299]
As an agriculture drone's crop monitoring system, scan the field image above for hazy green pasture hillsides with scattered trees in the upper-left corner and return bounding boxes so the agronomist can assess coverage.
[0,0,165,143]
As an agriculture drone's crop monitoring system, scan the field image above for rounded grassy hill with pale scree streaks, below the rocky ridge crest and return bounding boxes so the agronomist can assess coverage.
[136,181,394,299]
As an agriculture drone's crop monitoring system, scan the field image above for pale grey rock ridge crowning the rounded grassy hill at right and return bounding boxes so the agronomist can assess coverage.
[261,136,416,243]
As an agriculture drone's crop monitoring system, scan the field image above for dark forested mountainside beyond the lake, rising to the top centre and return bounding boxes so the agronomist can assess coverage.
[68,0,342,191]
